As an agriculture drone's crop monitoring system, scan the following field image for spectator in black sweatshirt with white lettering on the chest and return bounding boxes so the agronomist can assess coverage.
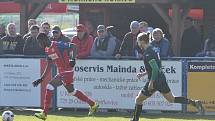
[1,23,24,54]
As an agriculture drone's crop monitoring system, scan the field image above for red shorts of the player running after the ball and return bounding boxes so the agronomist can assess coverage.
[56,71,74,85]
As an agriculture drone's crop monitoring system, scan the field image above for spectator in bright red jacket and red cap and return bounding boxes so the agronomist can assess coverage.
[71,24,93,58]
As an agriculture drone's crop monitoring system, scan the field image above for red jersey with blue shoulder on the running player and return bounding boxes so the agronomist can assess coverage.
[45,41,72,73]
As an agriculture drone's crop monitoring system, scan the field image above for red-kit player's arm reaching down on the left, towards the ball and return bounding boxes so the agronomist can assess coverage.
[32,59,51,87]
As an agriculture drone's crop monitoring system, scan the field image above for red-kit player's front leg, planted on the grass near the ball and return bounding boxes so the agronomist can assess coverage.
[35,75,62,120]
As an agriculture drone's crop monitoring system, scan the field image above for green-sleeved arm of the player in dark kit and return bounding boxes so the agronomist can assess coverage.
[149,59,159,81]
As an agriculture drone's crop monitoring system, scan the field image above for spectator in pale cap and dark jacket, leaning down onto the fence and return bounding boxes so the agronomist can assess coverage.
[115,21,139,58]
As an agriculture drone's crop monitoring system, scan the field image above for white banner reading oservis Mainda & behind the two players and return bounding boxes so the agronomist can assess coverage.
[57,60,182,110]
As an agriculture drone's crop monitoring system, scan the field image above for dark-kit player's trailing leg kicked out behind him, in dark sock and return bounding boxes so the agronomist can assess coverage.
[162,91,205,115]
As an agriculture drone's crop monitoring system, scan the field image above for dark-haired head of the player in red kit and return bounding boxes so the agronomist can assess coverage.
[37,33,50,48]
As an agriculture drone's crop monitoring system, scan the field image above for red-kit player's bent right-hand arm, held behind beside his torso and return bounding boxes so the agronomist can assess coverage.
[69,43,78,67]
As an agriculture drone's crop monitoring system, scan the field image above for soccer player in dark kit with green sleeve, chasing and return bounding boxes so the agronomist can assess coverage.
[130,33,204,121]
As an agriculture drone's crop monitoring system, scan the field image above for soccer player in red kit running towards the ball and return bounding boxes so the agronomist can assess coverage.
[32,33,99,120]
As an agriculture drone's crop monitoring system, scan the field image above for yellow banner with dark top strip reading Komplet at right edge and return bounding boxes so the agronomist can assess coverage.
[187,61,215,112]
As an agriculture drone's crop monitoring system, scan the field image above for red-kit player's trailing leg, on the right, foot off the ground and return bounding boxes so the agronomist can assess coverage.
[63,71,99,116]
